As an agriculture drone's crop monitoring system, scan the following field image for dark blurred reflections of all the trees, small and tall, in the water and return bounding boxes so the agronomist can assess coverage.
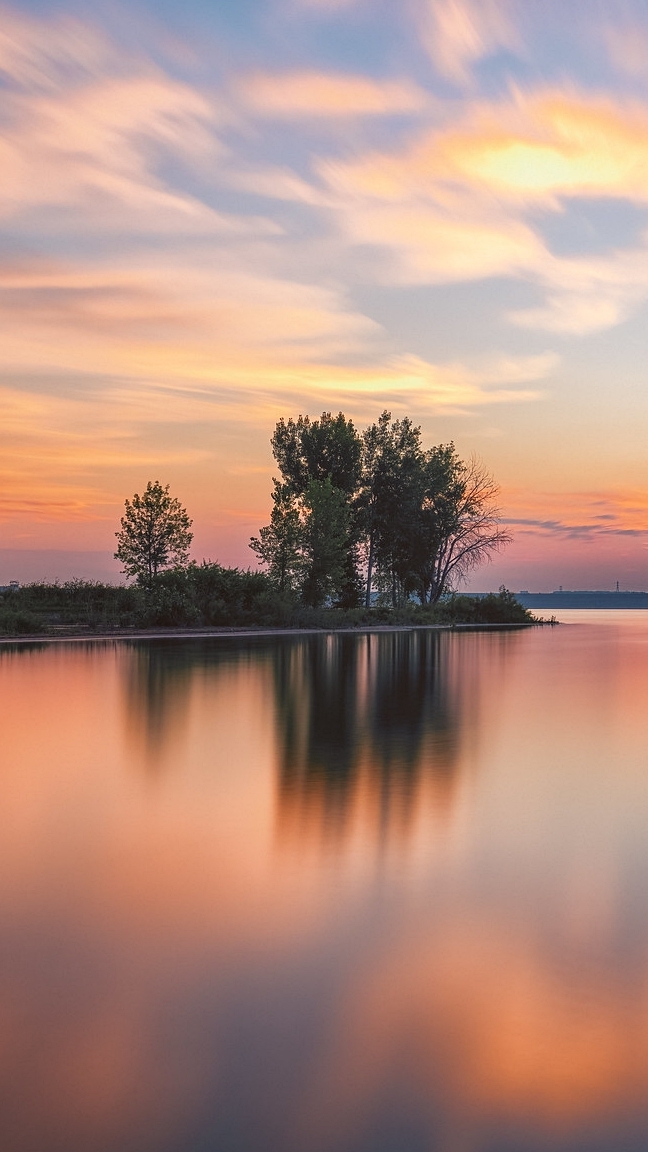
[123,631,493,843]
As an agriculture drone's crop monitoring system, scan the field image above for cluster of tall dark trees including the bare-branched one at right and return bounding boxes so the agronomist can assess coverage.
[250,411,510,607]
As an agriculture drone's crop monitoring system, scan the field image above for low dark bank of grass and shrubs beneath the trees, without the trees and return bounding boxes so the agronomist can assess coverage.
[0,564,534,636]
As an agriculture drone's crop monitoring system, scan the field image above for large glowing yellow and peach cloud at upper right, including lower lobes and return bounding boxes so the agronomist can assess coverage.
[317,91,648,334]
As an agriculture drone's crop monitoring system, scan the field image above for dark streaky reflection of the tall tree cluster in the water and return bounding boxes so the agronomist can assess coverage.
[273,632,475,839]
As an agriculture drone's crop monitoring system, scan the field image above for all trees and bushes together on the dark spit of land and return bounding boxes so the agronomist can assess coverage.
[0,411,518,635]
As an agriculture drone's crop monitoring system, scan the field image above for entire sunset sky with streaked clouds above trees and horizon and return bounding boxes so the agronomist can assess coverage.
[0,0,648,590]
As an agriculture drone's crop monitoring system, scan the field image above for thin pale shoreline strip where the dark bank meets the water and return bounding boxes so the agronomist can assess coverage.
[0,620,537,646]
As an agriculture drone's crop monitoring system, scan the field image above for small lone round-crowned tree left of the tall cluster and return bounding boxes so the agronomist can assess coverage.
[114,480,194,585]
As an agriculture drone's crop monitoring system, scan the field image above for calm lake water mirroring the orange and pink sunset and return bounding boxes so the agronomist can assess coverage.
[0,612,648,1152]
